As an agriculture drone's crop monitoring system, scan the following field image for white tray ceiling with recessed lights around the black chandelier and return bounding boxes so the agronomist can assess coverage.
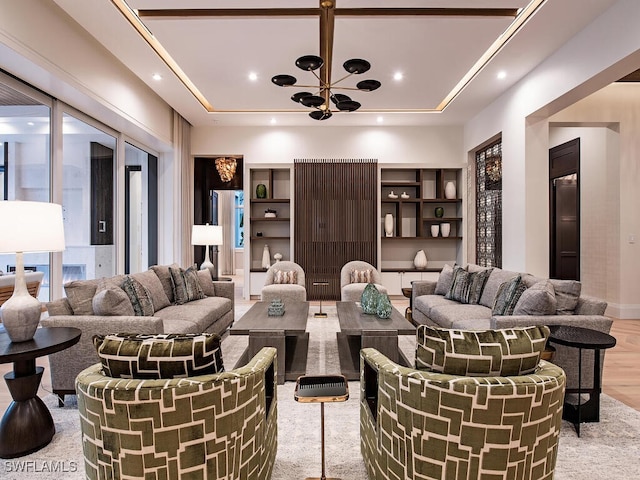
[54,0,615,126]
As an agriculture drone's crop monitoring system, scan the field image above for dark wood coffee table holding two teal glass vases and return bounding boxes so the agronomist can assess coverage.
[336,302,416,380]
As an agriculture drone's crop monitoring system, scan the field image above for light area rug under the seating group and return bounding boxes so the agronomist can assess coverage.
[0,306,640,480]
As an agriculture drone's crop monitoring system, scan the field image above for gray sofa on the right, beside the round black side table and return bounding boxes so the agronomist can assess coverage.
[411,264,613,410]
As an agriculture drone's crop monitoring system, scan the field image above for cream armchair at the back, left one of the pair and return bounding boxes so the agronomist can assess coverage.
[260,261,307,304]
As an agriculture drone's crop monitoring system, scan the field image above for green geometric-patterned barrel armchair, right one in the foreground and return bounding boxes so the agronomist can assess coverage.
[360,348,565,480]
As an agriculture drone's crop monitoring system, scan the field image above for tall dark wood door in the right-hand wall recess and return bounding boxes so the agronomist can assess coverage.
[549,139,580,280]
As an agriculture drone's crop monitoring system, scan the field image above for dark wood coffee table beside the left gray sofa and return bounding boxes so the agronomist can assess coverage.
[229,302,309,384]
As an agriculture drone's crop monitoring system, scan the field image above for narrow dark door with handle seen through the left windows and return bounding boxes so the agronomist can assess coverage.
[91,142,114,245]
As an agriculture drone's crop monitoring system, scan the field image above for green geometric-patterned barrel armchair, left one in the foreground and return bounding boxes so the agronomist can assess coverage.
[76,347,277,480]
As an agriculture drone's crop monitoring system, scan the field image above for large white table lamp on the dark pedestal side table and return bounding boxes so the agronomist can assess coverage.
[0,200,64,342]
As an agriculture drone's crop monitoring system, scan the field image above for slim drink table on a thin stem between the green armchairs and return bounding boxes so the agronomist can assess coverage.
[294,375,349,480]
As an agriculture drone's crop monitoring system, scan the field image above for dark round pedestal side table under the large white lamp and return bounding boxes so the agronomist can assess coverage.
[0,327,82,458]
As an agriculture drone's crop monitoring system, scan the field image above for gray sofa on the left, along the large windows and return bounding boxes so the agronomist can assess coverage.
[41,264,234,405]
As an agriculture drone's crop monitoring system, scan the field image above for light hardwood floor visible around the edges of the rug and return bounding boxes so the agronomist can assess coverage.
[0,294,640,413]
